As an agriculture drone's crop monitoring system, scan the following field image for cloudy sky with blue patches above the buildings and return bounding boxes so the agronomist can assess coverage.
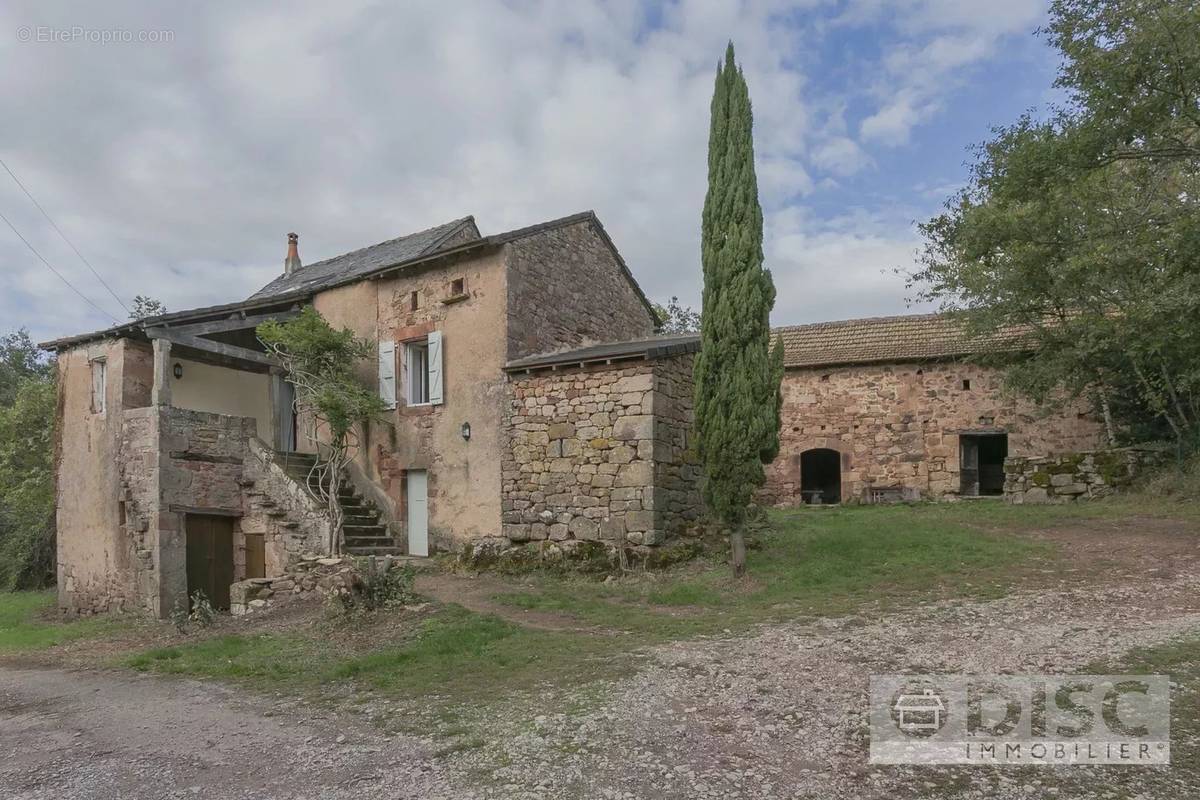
[0,0,1057,339]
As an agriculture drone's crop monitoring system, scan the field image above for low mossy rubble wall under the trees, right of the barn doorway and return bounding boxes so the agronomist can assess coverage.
[1004,447,1165,504]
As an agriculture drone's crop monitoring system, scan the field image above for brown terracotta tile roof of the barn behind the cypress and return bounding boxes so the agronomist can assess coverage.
[774,314,1024,367]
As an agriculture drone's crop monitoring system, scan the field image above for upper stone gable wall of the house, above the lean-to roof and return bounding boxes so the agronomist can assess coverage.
[505,221,654,359]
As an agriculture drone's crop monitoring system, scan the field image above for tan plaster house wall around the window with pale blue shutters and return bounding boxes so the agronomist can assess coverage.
[314,252,506,548]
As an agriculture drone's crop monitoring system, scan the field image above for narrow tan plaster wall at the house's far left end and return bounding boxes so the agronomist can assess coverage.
[56,339,152,613]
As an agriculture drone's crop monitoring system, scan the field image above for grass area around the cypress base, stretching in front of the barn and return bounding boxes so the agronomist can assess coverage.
[487,504,1058,638]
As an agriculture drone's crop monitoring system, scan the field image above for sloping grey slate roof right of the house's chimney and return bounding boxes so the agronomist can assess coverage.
[250,217,479,300]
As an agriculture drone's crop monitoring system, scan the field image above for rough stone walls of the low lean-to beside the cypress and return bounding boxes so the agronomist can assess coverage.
[502,357,698,556]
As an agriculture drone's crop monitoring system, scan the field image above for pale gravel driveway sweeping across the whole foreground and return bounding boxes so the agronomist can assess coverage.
[0,520,1200,800]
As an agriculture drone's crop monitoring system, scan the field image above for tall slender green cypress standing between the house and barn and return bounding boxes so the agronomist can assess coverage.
[695,42,784,576]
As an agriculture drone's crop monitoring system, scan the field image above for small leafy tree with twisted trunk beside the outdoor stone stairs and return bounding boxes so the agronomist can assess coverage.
[258,306,384,554]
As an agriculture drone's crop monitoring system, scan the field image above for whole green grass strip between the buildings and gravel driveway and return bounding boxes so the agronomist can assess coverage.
[126,503,1190,702]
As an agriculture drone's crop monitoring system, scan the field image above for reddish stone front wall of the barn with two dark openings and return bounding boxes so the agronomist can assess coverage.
[763,362,1103,505]
